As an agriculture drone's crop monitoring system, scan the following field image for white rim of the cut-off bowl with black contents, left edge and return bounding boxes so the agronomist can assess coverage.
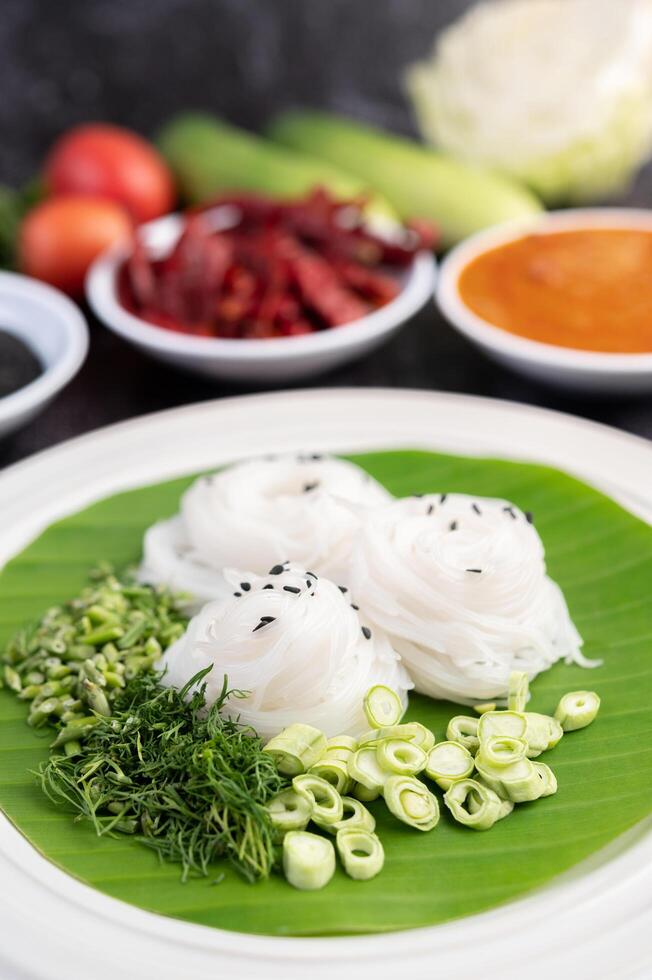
[0,272,88,422]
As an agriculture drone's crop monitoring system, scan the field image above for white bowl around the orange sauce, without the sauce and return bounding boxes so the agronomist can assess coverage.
[436,208,652,394]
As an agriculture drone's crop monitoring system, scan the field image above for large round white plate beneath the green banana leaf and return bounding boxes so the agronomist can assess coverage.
[0,389,652,980]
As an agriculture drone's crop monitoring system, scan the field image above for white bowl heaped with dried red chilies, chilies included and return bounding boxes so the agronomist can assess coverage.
[86,190,436,383]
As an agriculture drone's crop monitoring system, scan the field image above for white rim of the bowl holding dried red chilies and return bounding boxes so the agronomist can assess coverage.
[86,214,437,362]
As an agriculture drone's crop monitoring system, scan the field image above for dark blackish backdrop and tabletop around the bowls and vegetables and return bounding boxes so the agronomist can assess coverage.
[0,0,652,465]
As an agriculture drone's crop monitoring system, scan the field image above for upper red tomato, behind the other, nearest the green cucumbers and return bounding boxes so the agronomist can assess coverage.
[44,123,175,222]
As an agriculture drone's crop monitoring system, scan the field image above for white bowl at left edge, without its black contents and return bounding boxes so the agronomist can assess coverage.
[0,272,88,436]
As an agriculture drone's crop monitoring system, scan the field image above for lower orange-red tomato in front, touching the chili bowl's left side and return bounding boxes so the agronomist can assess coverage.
[18,194,133,296]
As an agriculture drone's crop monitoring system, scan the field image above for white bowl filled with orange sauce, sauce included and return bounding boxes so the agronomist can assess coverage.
[436,208,652,394]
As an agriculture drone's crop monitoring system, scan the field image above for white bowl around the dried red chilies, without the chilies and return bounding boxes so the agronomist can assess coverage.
[86,215,436,383]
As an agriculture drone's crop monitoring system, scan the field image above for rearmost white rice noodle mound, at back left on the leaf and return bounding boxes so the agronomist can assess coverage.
[141,454,392,609]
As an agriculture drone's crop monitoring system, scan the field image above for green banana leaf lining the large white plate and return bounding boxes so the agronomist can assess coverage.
[0,452,652,936]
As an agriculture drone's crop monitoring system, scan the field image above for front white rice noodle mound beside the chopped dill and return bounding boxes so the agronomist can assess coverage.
[161,564,412,738]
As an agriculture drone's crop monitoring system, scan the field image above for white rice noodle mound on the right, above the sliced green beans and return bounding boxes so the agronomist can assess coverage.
[352,494,592,704]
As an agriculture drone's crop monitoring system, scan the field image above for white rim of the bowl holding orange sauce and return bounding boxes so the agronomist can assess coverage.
[435,208,652,376]
